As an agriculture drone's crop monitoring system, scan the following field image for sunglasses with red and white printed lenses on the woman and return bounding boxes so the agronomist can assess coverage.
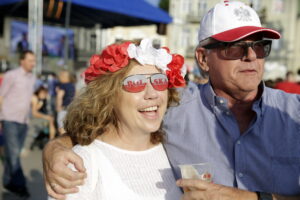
[122,73,169,93]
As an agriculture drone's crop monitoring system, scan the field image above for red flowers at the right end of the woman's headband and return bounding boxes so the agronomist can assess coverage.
[166,54,185,88]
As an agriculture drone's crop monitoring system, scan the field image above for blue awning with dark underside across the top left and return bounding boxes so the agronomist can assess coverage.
[0,0,172,28]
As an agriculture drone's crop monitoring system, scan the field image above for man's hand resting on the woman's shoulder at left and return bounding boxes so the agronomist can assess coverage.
[43,136,86,199]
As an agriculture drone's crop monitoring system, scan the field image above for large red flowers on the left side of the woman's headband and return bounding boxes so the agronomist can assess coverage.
[84,42,130,83]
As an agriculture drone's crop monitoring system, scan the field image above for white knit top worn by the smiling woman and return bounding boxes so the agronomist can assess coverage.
[63,140,181,200]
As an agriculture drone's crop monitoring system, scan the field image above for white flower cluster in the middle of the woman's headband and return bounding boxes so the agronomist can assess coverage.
[127,39,172,72]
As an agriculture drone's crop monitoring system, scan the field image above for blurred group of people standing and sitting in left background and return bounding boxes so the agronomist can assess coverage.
[0,50,80,197]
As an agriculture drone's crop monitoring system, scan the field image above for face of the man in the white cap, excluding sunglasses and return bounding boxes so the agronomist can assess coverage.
[207,37,264,96]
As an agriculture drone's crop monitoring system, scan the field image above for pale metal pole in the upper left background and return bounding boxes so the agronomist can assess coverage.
[27,0,43,74]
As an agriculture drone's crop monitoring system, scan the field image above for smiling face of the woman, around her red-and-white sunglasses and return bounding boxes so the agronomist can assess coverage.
[115,64,168,134]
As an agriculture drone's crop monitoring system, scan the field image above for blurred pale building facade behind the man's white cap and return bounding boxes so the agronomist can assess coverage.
[168,0,300,78]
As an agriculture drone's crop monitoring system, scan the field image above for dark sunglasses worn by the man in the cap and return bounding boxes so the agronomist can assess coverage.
[203,40,272,60]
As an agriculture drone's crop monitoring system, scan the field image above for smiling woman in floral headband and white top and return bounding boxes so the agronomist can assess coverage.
[47,39,185,200]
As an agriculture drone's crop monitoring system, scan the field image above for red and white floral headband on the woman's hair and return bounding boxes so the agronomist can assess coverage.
[84,39,186,88]
